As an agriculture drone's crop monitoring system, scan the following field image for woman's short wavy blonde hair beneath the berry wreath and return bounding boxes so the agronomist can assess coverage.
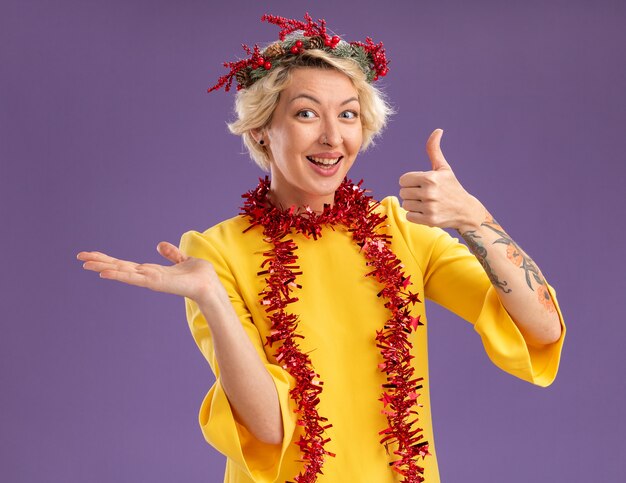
[228,49,393,171]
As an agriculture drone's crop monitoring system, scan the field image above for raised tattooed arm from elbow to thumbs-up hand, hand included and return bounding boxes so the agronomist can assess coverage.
[400,129,561,346]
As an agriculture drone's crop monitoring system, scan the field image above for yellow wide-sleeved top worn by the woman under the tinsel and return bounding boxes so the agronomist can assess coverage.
[180,197,565,483]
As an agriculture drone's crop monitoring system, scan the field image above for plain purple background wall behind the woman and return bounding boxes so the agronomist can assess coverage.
[0,0,626,483]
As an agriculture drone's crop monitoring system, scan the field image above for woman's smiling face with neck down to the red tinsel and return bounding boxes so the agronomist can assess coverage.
[261,67,363,211]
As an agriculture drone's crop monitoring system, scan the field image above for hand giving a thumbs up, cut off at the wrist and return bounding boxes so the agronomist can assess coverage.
[400,129,486,233]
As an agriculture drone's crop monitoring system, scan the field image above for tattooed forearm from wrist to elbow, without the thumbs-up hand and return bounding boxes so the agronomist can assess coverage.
[458,207,561,346]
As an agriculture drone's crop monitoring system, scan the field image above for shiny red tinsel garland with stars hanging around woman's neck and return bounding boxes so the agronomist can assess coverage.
[241,177,429,483]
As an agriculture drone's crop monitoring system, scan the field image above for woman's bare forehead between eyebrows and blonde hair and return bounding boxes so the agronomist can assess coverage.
[281,67,358,102]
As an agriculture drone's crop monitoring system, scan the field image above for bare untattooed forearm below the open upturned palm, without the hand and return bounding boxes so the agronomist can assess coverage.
[198,287,283,444]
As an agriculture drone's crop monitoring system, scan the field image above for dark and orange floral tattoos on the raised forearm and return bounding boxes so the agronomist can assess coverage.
[459,214,556,312]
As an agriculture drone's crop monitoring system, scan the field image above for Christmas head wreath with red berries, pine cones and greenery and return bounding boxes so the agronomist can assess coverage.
[208,13,389,92]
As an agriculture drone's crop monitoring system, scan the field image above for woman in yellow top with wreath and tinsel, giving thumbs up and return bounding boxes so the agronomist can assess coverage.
[78,15,565,483]
